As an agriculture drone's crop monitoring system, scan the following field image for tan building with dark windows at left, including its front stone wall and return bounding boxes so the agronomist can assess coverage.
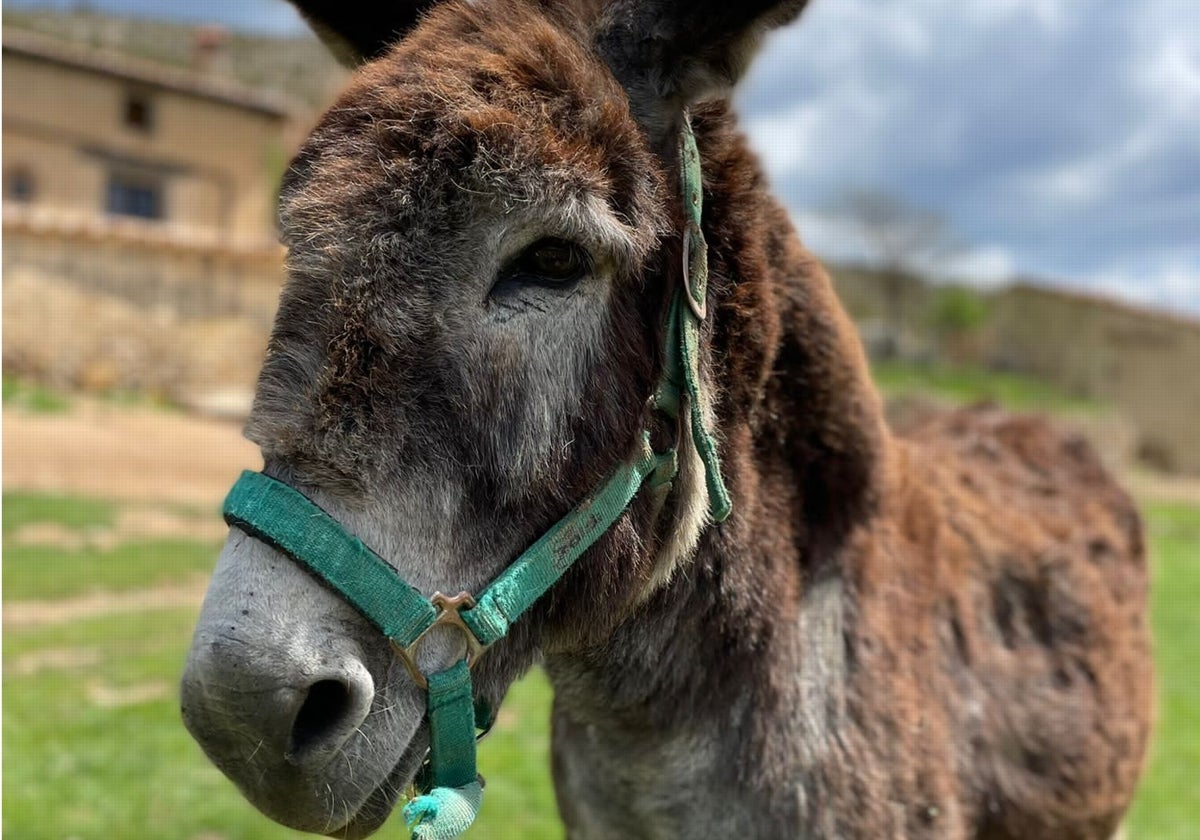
[2,26,304,412]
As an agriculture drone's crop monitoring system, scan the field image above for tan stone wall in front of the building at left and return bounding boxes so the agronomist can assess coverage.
[4,209,283,413]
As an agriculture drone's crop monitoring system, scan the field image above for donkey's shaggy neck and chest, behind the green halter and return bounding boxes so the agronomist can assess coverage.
[547,106,888,836]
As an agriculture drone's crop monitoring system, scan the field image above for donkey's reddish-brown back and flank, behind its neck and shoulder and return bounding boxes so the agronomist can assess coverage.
[839,408,1152,838]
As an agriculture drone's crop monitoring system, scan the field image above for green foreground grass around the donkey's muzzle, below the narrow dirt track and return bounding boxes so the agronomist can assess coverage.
[4,611,560,840]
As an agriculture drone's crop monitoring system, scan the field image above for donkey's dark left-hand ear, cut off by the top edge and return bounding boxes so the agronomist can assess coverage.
[292,0,436,67]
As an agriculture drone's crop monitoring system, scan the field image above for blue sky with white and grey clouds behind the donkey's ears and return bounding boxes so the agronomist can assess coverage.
[10,0,1200,316]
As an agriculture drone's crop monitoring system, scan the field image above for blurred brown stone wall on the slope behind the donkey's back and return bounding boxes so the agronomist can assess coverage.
[830,266,1200,474]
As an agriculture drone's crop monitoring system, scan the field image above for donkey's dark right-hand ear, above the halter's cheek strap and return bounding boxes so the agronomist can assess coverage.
[595,0,808,143]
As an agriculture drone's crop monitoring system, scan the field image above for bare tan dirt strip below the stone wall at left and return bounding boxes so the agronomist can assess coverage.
[4,402,262,508]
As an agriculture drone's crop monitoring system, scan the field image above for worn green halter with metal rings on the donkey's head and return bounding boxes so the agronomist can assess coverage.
[224,120,731,840]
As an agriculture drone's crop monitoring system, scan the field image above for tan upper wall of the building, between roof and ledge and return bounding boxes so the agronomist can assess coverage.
[4,52,288,245]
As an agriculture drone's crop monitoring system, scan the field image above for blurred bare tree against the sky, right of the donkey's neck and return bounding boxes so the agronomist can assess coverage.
[830,190,958,356]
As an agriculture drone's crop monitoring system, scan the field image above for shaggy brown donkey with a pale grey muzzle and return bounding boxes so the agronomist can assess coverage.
[181,0,1152,840]
